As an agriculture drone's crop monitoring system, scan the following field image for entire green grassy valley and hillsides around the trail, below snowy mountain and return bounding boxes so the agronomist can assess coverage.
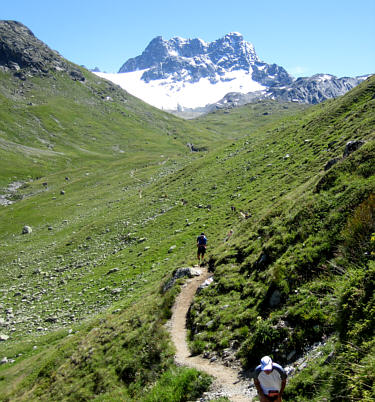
[0,21,375,402]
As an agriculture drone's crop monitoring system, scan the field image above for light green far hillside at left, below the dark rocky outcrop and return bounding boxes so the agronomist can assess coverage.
[0,65,232,184]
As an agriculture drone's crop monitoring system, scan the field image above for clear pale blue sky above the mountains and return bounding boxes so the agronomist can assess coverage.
[0,0,375,77]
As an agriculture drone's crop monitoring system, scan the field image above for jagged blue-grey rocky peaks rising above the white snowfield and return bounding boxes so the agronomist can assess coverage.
[119,32,292,85]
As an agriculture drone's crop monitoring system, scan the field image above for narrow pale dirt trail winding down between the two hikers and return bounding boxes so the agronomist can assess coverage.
[170,267,255,402]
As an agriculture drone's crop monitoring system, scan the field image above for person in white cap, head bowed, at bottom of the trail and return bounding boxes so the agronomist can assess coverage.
[254,356,287,402]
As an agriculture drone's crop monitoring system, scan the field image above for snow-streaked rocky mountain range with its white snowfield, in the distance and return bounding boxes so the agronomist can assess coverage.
[98,32,366,112]
